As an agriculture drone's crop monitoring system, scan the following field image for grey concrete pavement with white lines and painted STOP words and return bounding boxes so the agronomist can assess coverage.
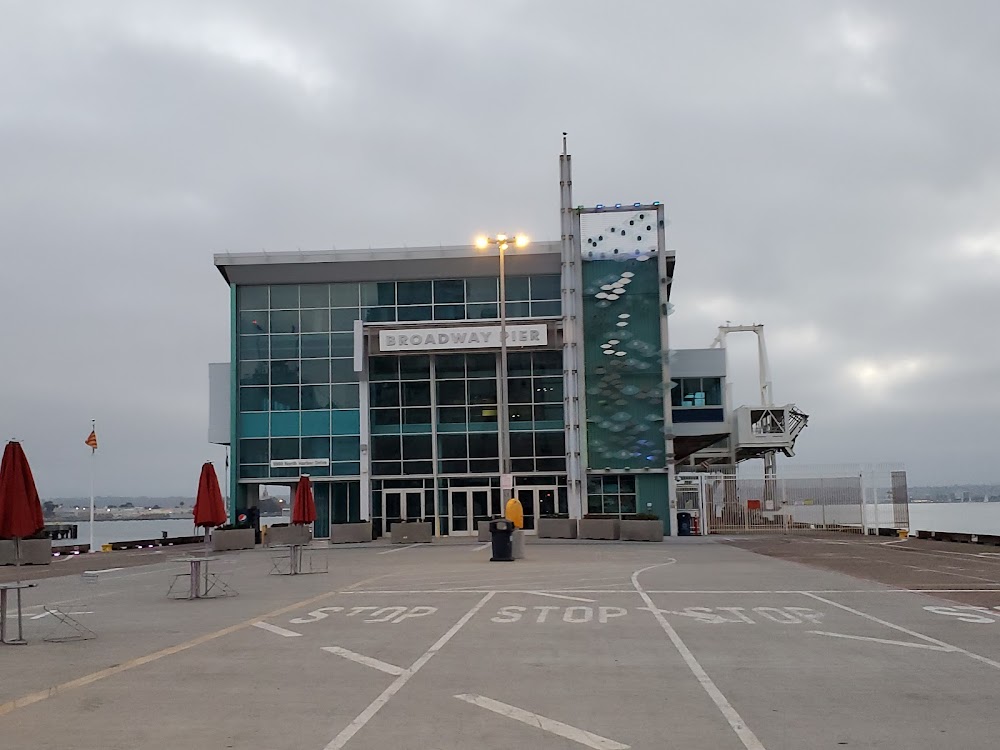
[0,540,1000,750]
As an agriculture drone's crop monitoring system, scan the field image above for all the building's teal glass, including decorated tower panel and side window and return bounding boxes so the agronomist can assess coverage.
[233,236,688,538]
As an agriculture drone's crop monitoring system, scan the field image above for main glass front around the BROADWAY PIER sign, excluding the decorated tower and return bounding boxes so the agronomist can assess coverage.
[235,274,566,536]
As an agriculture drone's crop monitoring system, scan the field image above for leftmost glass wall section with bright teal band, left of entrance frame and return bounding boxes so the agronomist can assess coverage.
[236,284,361,479]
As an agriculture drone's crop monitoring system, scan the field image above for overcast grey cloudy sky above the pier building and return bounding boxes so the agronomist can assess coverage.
[0,0,1000,496]
